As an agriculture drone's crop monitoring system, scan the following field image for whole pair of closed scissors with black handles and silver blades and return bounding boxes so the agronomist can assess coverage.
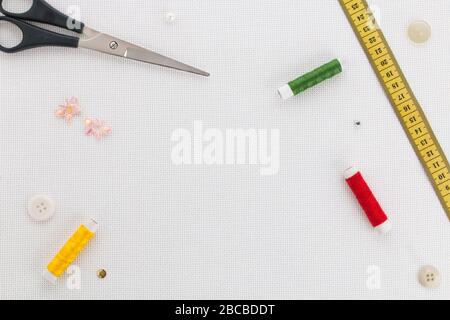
[0,0,209,77]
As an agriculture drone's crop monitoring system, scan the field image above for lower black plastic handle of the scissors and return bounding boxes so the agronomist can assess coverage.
[0,17,80,53]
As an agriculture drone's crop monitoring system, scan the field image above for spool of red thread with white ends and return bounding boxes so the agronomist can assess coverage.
[344,167,392,233]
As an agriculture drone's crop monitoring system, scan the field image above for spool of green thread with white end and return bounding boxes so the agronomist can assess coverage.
[278,59,342,100]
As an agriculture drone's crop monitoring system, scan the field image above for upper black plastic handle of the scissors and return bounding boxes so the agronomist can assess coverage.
[0,0,84,33]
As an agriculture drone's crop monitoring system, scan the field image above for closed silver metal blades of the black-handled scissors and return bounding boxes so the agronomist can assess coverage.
[79,27,209,77]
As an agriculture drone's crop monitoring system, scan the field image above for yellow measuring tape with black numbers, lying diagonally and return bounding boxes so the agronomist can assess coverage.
[339,0,450,219]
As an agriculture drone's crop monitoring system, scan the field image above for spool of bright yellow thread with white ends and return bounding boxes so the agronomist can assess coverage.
[44,219,97,284]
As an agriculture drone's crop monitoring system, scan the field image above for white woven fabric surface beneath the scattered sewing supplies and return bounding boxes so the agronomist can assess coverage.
[0,0,450,299]
